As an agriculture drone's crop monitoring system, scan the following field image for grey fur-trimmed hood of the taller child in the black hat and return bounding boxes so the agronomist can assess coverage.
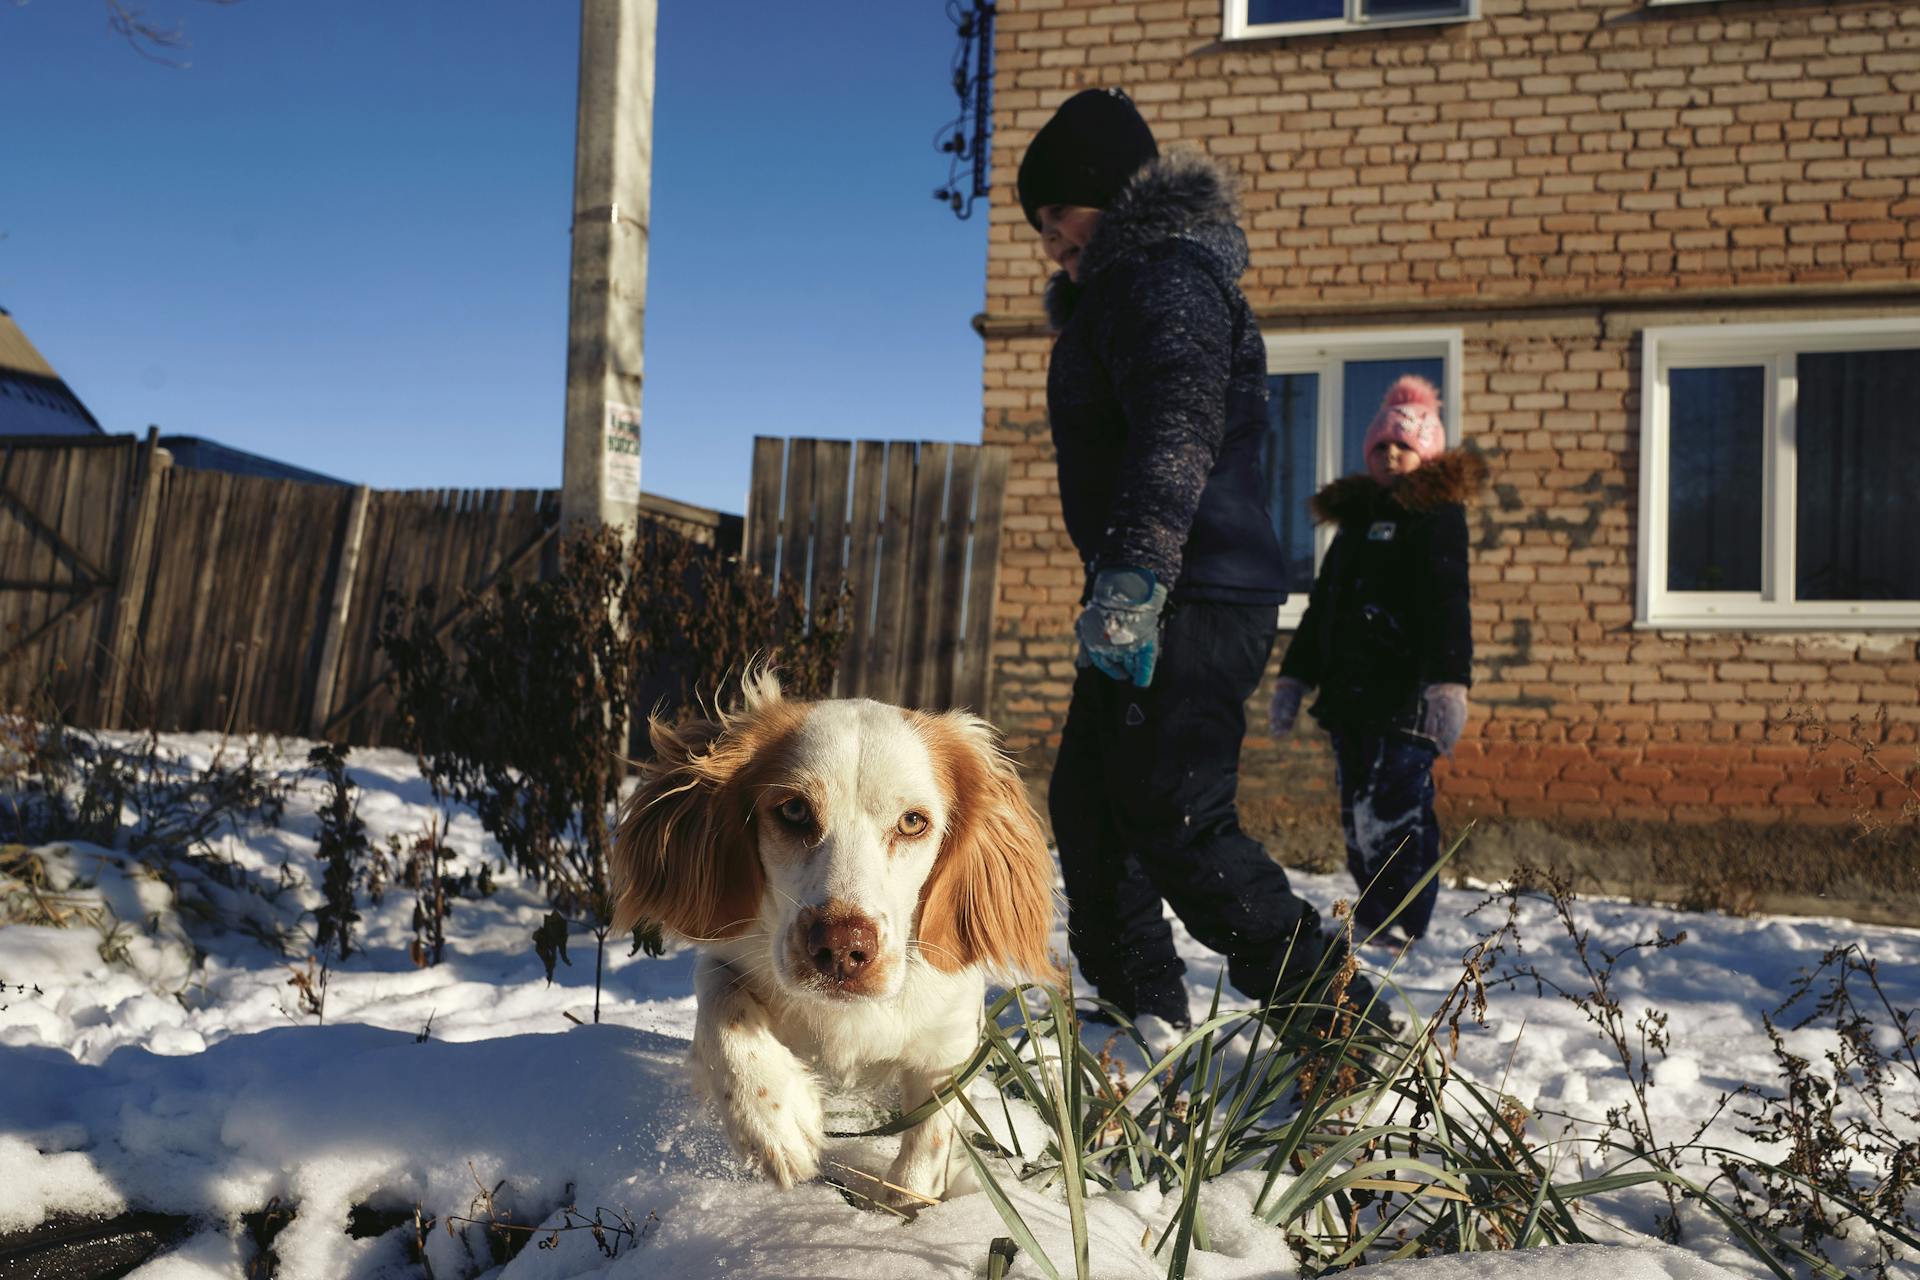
[1046,150,1246,330]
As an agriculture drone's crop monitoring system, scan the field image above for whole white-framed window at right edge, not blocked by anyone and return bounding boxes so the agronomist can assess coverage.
[1638,317,1920,628]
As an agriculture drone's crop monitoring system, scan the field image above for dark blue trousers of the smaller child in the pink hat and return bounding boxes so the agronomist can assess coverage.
[1332,729,1440,938]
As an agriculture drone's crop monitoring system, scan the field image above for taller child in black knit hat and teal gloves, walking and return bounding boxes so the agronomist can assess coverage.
[1020,88,1371,1027]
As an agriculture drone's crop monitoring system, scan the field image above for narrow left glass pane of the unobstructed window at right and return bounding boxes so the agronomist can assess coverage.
[1667,365,1766,591]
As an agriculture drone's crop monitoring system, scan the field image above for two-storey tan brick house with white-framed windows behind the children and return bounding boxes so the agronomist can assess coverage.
[977,0,1920,882]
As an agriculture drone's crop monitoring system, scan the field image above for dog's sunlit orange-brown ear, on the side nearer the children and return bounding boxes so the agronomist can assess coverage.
[914,712,1066,984]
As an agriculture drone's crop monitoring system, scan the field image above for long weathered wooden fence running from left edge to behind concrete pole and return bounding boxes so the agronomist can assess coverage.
[0,434,737,743]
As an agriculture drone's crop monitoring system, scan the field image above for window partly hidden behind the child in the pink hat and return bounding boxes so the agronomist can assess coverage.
[1261,330,1461,628]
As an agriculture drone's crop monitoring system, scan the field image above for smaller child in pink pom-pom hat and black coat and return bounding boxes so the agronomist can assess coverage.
[1269,374,1486,940]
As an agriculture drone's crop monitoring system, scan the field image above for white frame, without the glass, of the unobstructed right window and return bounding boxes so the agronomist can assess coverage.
[1634,317,1920,631]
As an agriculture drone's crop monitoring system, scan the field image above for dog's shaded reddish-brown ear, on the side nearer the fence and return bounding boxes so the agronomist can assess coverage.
[609,685,797,942]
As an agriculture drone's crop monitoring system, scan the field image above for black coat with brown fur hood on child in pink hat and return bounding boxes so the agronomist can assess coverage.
[1281,449,1486,731]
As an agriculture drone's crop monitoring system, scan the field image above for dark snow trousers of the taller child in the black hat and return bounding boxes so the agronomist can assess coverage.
[1048,601,1323,1023]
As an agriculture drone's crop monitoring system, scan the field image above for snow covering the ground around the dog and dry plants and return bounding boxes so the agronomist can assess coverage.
[0,737,1920,1280]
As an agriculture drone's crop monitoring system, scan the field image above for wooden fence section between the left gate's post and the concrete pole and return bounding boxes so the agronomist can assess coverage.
[147,470,559,743]
